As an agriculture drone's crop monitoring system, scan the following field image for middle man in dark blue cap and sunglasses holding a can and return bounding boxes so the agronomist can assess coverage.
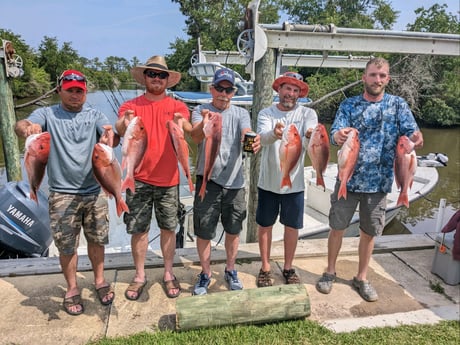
[191,68,259,295]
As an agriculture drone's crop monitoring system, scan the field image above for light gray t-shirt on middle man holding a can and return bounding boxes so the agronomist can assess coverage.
[192,103,251,189]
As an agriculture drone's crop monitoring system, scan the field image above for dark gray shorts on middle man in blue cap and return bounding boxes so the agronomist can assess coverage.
[193,176,246,240]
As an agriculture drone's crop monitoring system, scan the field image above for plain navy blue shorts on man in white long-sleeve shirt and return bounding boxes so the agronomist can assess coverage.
[256,188,305,229]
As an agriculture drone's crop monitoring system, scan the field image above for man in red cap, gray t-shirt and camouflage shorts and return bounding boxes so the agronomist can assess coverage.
[15,70,119,315]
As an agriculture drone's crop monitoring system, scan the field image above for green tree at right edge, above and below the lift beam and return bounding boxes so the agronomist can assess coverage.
[395,4,460,126]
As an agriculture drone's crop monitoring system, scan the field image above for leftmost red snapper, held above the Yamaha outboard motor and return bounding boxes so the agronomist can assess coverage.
[24,132,51,204]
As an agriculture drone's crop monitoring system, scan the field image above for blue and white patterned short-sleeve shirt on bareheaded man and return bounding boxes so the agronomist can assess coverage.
[330,94,419,193]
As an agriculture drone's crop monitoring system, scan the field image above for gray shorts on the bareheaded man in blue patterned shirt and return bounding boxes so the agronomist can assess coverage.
[329,182,387,236]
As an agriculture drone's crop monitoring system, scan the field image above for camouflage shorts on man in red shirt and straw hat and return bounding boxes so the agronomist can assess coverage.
[123,181,179,235]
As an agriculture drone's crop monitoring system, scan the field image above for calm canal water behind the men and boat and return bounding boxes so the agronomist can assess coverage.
[0,90,460,238]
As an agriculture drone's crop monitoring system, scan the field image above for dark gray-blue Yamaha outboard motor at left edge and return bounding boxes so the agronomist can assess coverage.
[0,181,53,258]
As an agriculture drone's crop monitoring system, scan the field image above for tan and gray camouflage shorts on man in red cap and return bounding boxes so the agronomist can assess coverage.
[48,192,109,255]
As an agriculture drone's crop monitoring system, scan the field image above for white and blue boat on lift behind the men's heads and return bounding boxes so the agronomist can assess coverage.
[168,62,311,108]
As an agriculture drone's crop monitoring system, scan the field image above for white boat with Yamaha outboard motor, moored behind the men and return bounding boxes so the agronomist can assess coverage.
[0,155,439,258]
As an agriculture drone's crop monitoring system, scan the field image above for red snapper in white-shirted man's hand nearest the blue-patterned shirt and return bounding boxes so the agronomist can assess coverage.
[307,123,329,190]
